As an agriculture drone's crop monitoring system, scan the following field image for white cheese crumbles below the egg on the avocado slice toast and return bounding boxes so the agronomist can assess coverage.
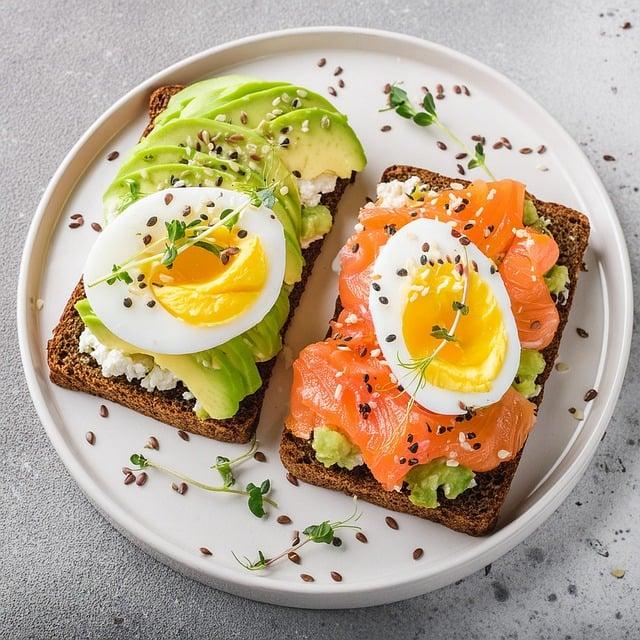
[78,328,189,400]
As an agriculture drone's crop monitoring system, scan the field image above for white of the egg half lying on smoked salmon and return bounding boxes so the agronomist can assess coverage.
[369,218,520,415]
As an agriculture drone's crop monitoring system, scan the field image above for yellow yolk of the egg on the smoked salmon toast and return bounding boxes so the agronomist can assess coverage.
[402,262,508,393]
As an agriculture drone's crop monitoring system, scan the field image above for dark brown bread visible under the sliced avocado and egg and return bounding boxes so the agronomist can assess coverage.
[47,85,354,443]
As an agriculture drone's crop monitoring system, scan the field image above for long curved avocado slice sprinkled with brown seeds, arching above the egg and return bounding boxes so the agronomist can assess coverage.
[132,118,302,234]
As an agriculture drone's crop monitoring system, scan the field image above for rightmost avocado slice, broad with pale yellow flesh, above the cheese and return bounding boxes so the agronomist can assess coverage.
[261,109,367,180]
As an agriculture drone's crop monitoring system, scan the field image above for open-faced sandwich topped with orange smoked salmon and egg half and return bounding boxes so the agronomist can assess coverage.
[280,166,589,535]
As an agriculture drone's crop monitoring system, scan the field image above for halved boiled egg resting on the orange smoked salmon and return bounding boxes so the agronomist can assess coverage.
[369,219,520,415]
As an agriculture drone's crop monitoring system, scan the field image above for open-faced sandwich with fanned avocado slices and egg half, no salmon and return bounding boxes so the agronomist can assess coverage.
[48,76,366,442]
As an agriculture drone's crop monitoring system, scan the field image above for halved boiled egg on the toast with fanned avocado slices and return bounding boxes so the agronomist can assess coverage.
[83,187,285,354]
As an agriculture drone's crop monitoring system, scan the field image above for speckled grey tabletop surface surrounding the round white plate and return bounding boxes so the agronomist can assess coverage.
[0,0,640,640]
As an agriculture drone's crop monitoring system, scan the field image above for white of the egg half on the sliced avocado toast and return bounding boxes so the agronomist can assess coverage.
[83,187,286,355]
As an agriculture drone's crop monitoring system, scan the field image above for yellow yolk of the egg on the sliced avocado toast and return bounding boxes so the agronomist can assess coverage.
[146,227,268,327]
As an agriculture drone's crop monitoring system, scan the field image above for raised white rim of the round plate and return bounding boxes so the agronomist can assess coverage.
[17,26,633,608]
